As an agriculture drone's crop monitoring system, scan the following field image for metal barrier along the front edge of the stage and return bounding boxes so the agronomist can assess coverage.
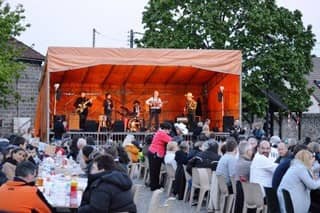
[51,131,230,145]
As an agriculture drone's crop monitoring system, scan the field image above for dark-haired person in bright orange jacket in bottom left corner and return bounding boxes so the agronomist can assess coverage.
[0,161,52,213]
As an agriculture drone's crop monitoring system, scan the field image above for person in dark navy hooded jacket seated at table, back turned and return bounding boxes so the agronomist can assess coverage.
[78,154,137,213]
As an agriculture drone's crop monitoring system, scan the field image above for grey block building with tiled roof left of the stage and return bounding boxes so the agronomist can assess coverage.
[0,39,45,135]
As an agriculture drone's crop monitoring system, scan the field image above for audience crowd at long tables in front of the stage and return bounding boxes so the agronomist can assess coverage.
[0,119,320,213]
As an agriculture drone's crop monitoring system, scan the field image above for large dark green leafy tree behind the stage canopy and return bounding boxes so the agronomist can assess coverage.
[136,0,315,116]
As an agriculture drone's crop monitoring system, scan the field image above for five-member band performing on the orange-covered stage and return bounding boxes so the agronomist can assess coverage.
[74,90,197,132]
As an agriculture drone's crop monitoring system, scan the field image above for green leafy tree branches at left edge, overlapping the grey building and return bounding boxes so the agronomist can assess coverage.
[0,0,29,107]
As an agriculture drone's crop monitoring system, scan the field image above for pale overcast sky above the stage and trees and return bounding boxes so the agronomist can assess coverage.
[5,0,320,56]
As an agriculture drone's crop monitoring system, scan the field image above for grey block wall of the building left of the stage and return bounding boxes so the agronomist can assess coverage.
[0,63,42,135]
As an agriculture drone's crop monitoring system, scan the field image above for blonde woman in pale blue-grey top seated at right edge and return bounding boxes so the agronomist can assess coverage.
[277,150,320,213]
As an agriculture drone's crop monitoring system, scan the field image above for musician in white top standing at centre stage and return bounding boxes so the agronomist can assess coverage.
[146,90,162,130]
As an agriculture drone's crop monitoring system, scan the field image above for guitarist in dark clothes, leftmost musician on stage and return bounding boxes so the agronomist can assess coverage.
[74,92,92,129]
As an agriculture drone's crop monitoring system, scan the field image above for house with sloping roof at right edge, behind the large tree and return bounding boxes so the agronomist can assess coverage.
[305,57,320,113]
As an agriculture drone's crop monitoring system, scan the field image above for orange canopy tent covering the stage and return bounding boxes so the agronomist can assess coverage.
[35,47,242,141]
